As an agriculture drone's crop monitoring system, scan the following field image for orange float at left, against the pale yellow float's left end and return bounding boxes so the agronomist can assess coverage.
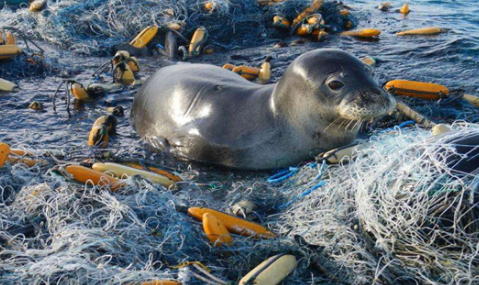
[65,165,126,191]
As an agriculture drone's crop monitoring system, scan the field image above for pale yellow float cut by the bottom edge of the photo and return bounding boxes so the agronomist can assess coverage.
[239,255,298,285]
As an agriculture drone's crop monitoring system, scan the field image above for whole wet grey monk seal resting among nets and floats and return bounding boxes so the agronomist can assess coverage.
[131,49,396,170]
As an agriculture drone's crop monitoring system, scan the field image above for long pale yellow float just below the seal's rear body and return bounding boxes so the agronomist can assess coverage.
[92,162,175,188]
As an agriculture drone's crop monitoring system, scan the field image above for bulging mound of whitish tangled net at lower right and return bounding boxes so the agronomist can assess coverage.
[280,122,479,284]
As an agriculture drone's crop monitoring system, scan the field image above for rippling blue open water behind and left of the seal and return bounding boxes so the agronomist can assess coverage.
[0,0,479,155]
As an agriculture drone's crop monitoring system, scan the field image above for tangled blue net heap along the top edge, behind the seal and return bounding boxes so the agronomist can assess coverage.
[0,0,351,54]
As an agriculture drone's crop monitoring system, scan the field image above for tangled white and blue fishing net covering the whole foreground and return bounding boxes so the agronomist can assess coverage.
[0,124,479,284]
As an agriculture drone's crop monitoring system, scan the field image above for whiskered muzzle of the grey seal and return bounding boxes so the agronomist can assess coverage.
[338,88,396,121]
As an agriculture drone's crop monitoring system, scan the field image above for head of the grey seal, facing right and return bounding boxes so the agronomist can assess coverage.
[277,49,396,127]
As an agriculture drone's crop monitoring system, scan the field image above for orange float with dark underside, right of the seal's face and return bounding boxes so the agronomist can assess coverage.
[384,80,449,100]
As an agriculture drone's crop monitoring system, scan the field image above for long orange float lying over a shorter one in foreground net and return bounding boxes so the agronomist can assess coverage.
[188,207,276,238]
